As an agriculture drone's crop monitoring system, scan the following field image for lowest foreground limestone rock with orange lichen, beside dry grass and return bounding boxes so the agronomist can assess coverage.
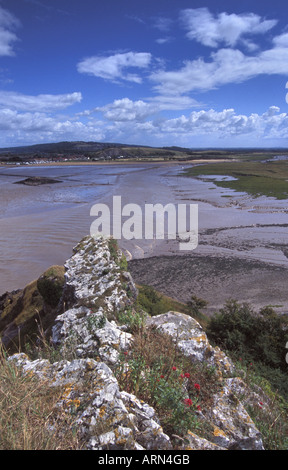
[9,353,172,450]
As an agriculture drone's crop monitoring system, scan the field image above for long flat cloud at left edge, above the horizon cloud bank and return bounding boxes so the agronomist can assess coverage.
[0,90,82,112]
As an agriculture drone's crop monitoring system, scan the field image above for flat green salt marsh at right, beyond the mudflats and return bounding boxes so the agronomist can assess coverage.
[183,160,288,199]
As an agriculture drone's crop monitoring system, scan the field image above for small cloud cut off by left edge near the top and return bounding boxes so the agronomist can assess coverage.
[0,6,20,56]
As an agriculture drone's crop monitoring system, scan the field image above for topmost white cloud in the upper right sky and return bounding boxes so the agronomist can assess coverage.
[180,8,277,47]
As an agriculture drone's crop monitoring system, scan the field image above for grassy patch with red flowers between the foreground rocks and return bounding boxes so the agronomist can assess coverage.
[114,328,221,445]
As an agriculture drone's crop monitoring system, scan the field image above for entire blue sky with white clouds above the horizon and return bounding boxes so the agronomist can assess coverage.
[0,0,288,148]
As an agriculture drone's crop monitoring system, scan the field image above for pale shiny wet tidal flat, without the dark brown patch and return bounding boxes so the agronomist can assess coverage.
[0,164,288,294]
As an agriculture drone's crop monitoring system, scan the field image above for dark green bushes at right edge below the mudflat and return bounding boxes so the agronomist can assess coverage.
[206,300,288,400]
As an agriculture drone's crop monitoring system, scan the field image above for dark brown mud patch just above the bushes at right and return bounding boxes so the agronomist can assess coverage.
[129,255,288,315]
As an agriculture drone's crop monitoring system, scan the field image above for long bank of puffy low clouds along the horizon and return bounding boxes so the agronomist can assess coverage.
[0,104,288,147]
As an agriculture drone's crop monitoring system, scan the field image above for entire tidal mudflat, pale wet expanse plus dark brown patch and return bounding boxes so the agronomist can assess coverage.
[0,163,288,313]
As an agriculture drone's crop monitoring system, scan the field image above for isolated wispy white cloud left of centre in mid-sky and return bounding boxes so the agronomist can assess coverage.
[77,52,152,83]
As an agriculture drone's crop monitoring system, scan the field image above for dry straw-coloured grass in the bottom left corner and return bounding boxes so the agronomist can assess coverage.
[0,349,81,450]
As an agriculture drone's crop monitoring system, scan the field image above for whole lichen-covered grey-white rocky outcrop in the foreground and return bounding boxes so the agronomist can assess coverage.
[4,237,263,450]
